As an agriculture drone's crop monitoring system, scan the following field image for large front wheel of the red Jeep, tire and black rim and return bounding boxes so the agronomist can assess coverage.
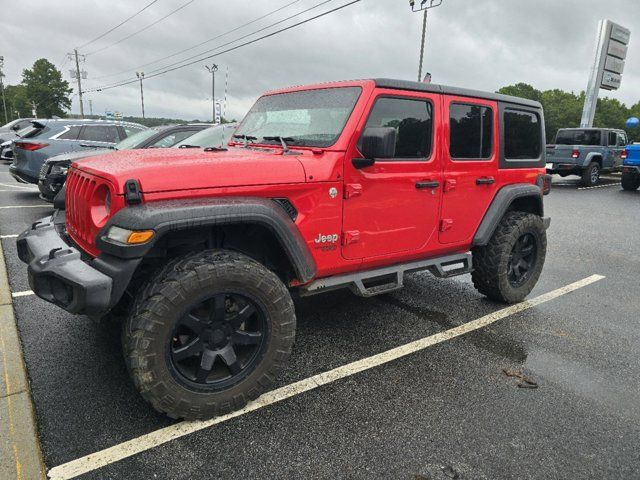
[123,250,296,419]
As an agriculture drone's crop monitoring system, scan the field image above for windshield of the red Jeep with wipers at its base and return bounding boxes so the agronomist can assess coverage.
[236,87,362,147]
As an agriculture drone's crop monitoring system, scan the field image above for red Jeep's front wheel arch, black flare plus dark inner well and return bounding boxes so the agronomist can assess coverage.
[96,197,316,283]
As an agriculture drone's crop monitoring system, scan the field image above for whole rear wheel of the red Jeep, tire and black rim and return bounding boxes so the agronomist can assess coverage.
[471,212,547,303]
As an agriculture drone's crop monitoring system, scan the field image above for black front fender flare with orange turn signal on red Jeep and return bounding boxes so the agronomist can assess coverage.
[96,197,316,283]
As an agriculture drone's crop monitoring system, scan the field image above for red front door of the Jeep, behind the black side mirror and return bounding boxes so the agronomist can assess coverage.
[342,90,442,259]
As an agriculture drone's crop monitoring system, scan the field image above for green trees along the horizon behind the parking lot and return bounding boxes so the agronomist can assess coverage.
[0,58,640,143]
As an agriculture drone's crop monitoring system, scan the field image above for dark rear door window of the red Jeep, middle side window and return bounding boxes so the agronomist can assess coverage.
[449,103,493,160]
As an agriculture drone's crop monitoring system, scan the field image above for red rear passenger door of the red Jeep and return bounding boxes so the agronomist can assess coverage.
[439,96,500,243]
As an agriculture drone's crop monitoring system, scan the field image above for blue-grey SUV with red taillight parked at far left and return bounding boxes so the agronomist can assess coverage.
[9,119,146,184]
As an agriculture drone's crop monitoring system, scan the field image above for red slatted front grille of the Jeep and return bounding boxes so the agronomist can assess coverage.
[65,168,98,253]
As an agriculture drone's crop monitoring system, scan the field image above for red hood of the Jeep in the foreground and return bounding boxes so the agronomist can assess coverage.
[74,147,306,193]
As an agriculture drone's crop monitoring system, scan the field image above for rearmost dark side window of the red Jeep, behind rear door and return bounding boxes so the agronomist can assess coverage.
[504,109,542,160]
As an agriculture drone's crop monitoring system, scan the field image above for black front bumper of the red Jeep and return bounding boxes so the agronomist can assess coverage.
[17,211,139,316]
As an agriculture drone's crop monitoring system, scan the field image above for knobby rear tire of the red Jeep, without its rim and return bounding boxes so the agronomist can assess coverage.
[471,211,547,303]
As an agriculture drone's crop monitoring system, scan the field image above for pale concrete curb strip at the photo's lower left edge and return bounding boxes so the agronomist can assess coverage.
[0,238,46,480]
